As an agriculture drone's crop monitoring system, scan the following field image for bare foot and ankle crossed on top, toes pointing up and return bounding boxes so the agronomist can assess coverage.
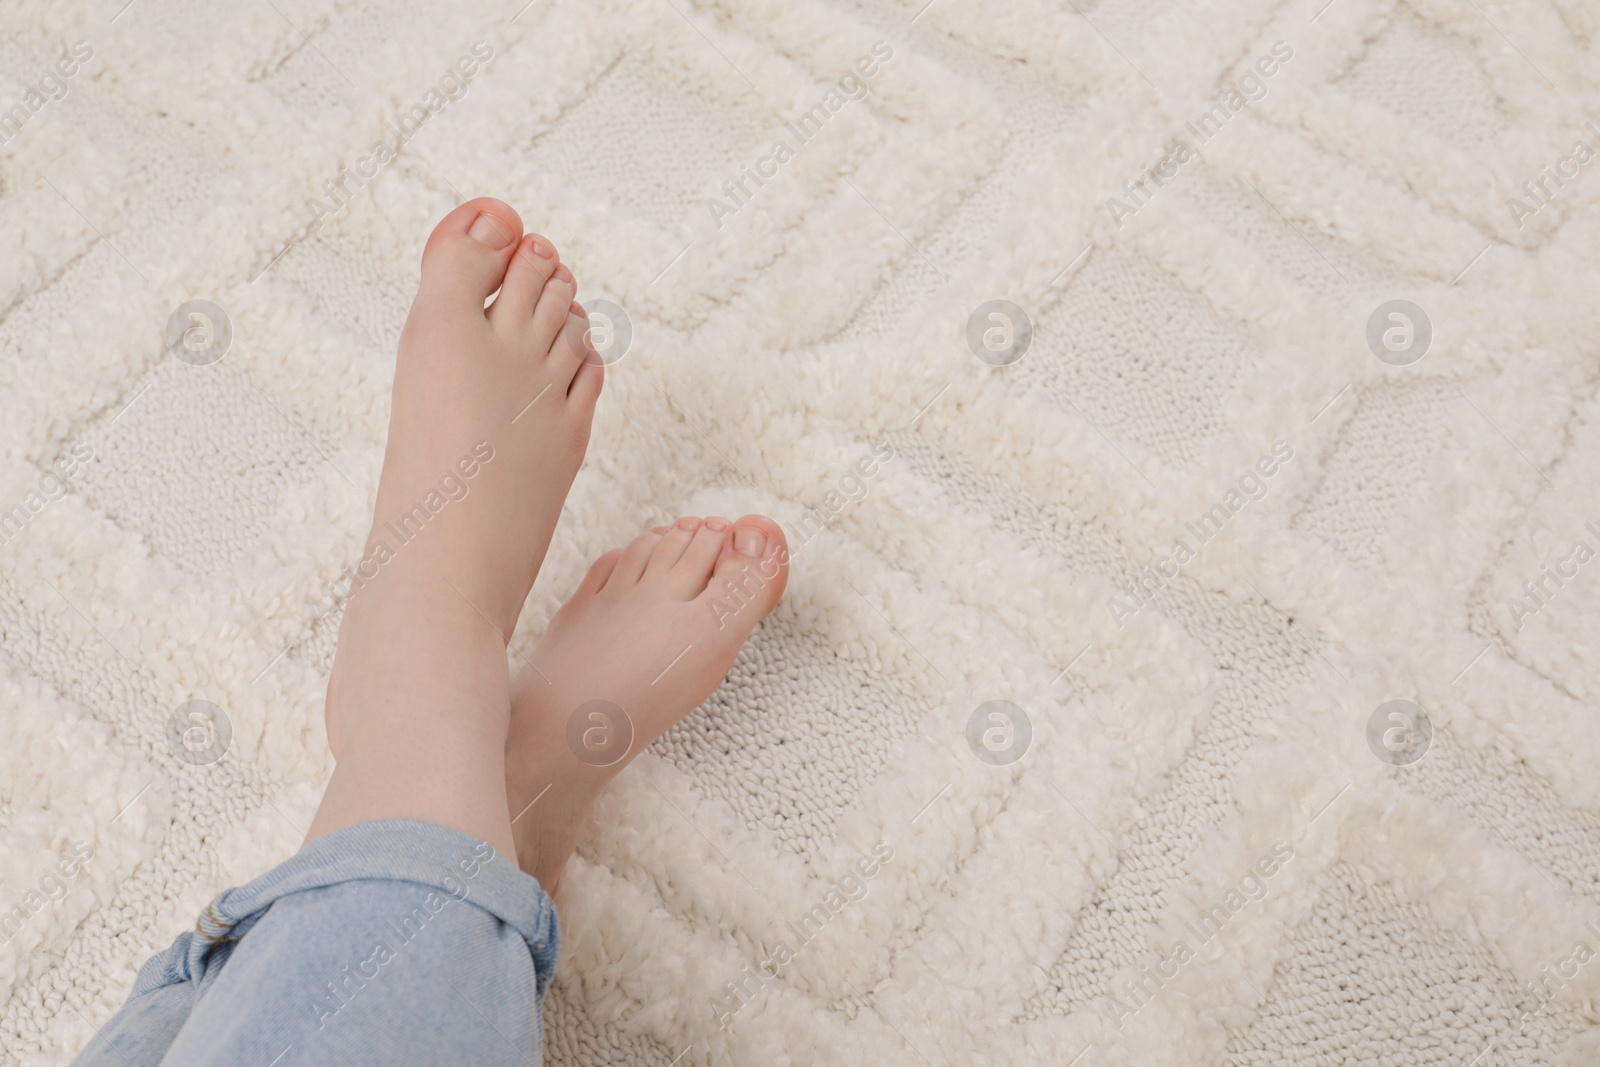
[310,198,603,848]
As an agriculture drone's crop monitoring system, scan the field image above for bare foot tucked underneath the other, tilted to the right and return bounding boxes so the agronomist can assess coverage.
[506,515,789,893]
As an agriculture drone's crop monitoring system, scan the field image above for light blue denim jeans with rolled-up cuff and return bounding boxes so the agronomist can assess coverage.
[75,819,558,1067]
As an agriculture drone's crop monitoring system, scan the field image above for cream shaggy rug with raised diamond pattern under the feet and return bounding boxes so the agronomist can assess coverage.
[0,0,1600,1067]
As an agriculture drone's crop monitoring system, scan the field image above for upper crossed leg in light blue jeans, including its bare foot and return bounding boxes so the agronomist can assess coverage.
[80,200,602,1067]
